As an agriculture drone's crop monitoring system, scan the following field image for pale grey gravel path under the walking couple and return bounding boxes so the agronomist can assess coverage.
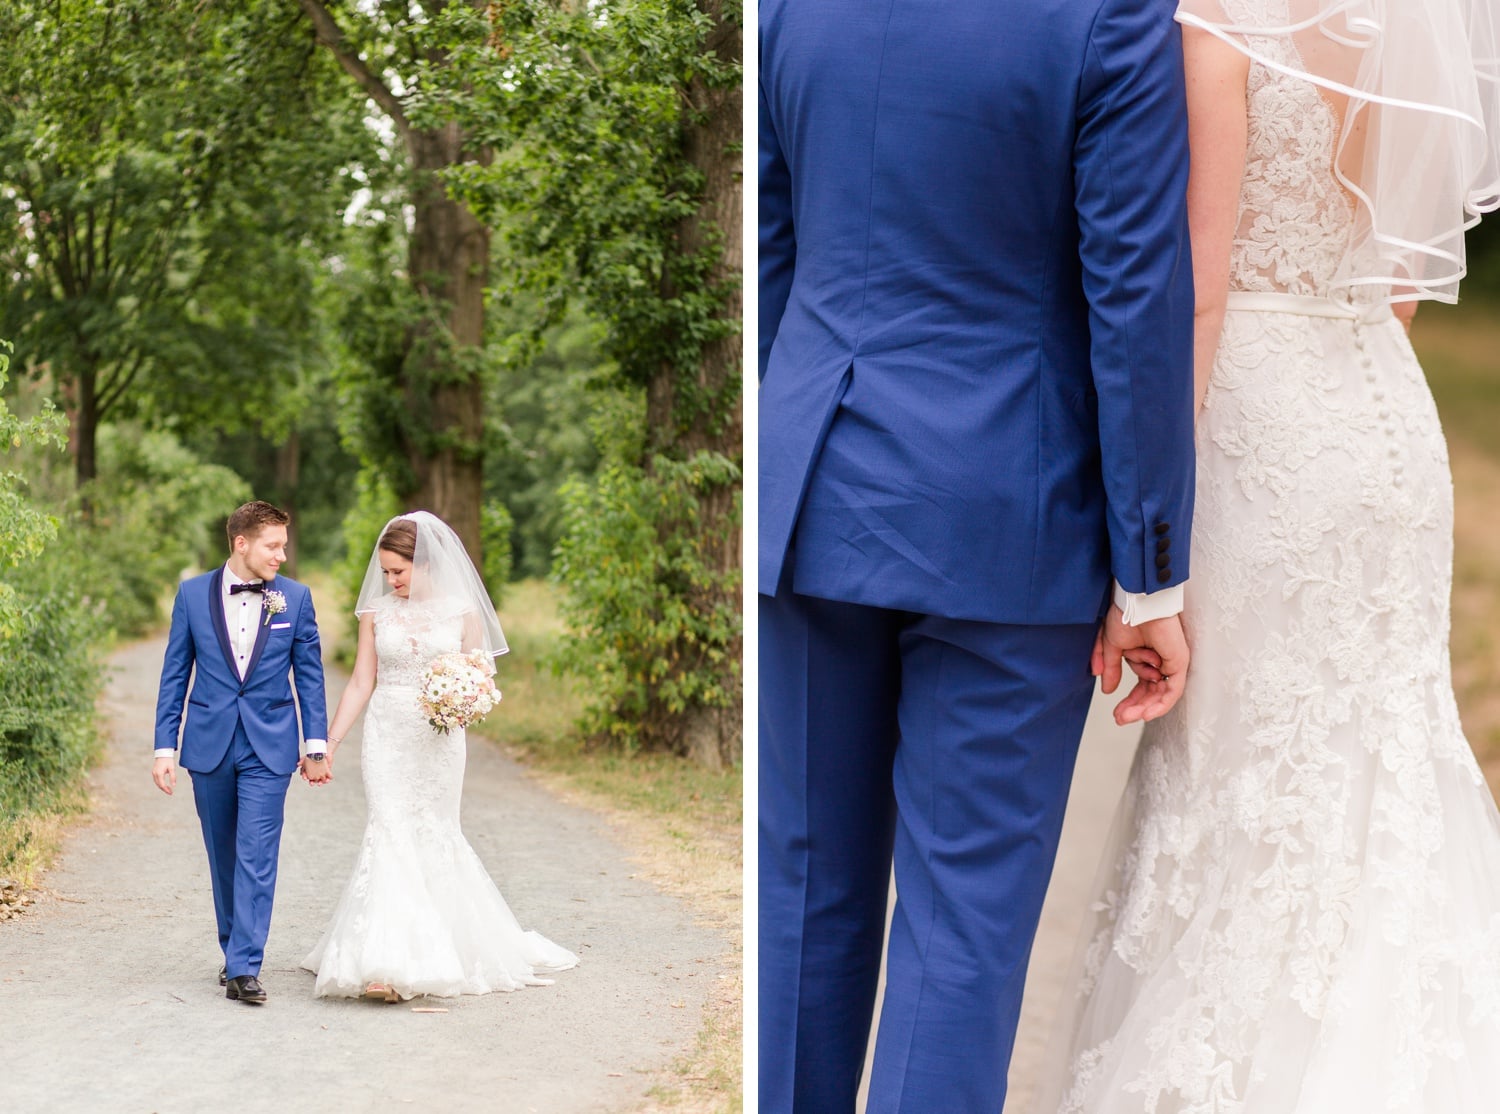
[0,640,729,1114]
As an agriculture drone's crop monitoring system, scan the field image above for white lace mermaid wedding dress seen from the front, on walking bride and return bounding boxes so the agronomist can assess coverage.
[303,595,578,997]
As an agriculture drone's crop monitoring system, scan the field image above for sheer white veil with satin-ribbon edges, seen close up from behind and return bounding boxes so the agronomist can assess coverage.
[1178,0,1500,301]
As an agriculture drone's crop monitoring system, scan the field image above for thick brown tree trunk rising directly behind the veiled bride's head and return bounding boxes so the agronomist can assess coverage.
[401,124,489,567]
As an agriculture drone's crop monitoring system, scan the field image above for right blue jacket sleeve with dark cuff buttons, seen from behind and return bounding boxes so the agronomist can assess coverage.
[1074,0,1194,592]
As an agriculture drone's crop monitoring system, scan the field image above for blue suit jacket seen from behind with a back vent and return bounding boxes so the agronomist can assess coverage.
[759,0,1194,622]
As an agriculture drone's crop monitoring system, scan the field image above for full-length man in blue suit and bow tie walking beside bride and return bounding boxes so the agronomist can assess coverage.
[152,502,329,1005]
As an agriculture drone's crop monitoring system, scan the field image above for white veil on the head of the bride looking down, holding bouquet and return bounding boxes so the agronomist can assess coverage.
[354,511,509,655]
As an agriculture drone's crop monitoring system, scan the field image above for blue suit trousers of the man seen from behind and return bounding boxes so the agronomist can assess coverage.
[759,588,1097,1114]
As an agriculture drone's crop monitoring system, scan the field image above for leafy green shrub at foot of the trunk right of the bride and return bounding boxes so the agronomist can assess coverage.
[555,440,741,751]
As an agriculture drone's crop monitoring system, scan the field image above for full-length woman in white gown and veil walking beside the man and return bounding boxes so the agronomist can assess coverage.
[303,511,578,1002]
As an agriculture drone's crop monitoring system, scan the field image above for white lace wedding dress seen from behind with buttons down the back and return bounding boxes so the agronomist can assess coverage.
[1040,10,1500,1114]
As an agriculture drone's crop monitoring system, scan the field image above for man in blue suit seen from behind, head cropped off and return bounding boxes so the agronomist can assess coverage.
[759,0,1194,1114]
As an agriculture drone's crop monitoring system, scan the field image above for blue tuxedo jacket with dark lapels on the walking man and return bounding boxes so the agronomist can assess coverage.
[155,567,329,774]
